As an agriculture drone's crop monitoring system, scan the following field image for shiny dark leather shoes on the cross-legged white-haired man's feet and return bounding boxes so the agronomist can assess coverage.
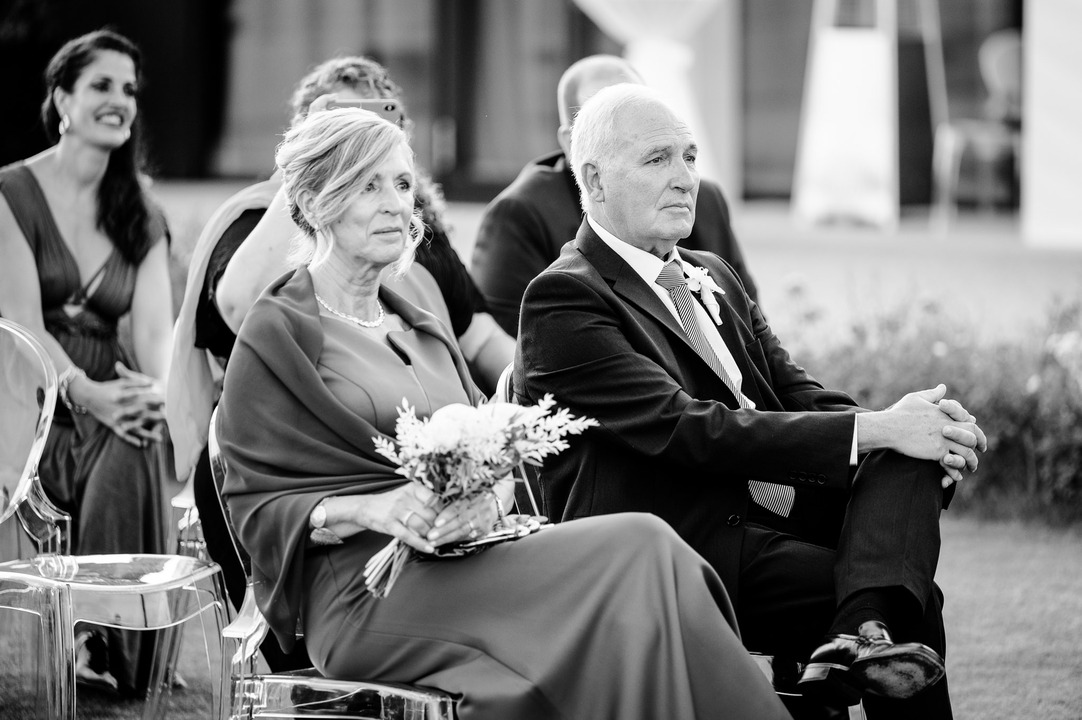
[797,620,945,705]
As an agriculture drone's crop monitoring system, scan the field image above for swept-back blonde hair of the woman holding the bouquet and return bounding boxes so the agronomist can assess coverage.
[275,108,424,275]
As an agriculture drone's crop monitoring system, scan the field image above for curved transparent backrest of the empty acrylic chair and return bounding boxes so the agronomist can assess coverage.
[0,317,69,552]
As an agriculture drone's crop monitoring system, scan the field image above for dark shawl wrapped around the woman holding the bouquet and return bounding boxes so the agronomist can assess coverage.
[217,269,480,651]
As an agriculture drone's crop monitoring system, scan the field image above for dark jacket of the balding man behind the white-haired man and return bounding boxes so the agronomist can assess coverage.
[471,152,756,337]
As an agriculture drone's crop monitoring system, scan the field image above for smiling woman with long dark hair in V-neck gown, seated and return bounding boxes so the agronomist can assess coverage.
[0,31,172,695]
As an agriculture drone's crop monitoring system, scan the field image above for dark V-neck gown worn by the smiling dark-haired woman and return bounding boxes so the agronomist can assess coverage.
[0,165,166,694]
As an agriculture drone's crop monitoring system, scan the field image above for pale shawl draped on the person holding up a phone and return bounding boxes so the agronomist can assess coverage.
[166,180,280,482]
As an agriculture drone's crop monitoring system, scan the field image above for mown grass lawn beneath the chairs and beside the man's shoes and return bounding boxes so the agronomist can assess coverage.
[0,516,1082,720]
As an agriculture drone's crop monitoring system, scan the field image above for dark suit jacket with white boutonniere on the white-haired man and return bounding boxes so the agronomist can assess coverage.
[514,221,859,598]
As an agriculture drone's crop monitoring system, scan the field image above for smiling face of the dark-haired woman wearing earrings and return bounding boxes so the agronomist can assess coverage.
[56,50,138,149]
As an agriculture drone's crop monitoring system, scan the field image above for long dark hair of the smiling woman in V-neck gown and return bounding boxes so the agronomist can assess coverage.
[41,29,157,264]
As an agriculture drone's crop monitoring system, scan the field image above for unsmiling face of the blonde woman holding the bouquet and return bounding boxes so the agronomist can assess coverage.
[330,144,413,269]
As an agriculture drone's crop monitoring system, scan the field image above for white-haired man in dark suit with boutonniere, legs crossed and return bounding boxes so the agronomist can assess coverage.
[514,84,987,719]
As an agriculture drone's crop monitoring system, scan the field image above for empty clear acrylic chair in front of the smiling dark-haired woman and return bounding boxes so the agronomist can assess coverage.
[0,318,227,720]
